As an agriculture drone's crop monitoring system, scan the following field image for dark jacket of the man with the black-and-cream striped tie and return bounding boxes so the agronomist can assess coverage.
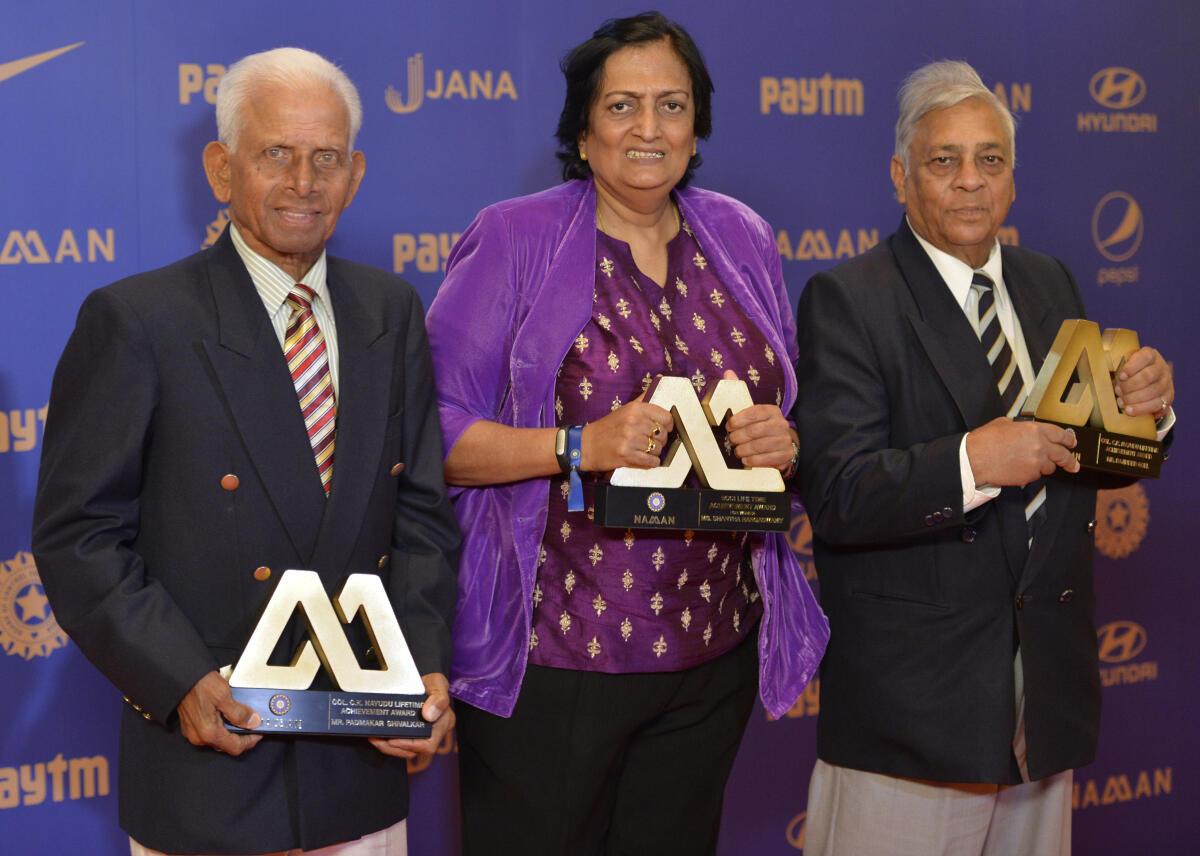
[793,222,1106,783]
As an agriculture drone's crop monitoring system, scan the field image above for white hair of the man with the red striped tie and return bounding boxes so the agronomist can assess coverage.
[217,48,362,151]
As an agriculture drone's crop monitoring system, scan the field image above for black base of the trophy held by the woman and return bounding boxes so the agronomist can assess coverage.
[595,485,792,532]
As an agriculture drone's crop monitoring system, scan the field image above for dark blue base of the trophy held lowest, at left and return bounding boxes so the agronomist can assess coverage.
[226,687,433,738]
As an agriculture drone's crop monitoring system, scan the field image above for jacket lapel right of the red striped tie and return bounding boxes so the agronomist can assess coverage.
[310,258,391,574]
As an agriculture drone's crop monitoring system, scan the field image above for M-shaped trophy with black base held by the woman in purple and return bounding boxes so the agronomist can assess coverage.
[595,377,792,532]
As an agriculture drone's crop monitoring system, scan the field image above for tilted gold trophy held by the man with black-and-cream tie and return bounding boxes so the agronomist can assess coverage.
[1021,318,1163,478]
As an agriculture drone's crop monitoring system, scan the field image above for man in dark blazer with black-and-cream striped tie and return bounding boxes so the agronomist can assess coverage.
[793,62,1174,856]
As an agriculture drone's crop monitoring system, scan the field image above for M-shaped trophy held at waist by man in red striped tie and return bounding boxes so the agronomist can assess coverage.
[226,570,432,737]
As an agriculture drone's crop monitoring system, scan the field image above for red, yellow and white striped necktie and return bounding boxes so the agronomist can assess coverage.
[283,282,337,496]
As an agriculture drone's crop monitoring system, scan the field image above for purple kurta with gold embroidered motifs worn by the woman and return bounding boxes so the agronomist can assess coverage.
[529,222,784,672]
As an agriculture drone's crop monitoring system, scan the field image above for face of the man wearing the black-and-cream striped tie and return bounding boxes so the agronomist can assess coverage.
[892,98,1016,268]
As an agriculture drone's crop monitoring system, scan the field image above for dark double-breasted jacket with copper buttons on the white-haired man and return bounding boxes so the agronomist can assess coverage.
[34,233,458,854]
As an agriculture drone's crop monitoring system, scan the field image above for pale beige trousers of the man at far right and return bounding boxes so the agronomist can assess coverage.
[804,652,1073,856]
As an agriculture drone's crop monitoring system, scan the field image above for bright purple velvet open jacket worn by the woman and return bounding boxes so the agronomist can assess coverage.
[426,181,829,717]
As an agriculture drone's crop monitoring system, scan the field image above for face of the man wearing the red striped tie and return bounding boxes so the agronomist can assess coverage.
[204,84,366,280]
